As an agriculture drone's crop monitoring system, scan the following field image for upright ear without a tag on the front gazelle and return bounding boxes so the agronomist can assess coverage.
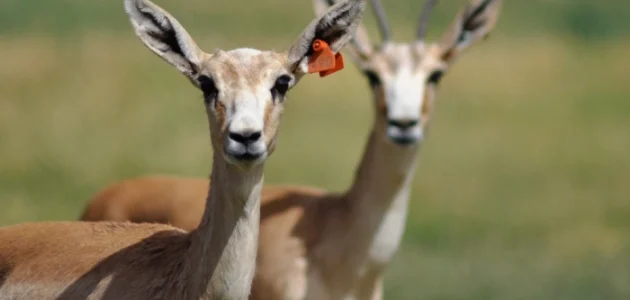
[125,0,206,82]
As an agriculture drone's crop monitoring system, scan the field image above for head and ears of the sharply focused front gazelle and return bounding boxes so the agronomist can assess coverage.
[125,0,365,167]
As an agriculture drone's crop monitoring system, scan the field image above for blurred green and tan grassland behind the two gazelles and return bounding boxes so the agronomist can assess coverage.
[0,0,630,299]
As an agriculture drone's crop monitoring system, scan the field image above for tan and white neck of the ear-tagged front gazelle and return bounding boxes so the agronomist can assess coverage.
[187,154,263,299]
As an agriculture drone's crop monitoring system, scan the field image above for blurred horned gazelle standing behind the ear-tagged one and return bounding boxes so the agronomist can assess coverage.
[83,0,501,299]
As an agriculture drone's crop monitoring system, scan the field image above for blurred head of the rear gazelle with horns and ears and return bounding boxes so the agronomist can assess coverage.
[314,0,502,145]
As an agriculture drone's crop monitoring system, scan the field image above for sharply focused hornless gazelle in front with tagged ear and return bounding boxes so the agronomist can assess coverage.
[0,0,365,300]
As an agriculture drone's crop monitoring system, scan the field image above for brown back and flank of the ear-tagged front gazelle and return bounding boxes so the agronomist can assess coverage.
[0,222,193,300]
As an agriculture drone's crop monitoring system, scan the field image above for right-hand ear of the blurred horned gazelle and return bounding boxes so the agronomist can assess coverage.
[439,0,503,63]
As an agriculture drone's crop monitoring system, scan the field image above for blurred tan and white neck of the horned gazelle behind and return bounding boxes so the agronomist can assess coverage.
[345,124,420,264]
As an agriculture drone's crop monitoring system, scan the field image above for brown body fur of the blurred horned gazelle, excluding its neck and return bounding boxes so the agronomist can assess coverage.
[82,176,348,299]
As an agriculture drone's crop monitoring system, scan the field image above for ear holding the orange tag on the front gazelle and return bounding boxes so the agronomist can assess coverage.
[287,0,365,76]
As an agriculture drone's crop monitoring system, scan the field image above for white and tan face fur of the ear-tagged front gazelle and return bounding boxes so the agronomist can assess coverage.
[210,48,287,165]
